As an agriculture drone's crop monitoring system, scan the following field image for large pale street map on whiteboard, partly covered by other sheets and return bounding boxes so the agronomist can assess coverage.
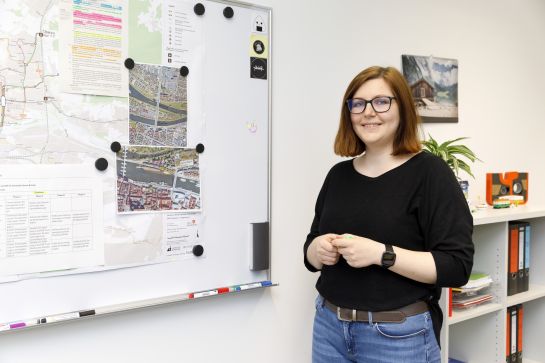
[0,0,203,282]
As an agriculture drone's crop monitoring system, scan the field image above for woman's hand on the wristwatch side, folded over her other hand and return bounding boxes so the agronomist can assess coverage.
[332,234,384,268]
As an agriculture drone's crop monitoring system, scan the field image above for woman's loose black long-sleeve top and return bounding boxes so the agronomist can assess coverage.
[304,152,474,342]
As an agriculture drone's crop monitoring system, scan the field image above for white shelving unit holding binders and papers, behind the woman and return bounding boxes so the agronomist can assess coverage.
[440,205,545,363]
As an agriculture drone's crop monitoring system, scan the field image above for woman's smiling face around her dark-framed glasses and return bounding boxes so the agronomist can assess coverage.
[350,78,399,149]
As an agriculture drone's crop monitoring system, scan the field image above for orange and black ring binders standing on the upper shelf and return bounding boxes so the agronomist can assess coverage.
[507,221,530,296]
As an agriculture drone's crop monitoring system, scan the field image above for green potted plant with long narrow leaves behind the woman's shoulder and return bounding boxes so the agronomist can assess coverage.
[422,134,480,199]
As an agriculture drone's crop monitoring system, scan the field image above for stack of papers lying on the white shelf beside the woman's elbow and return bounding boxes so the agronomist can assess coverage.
[451,272,494,309]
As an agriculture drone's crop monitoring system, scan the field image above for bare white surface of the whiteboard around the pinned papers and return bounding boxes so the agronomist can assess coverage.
[0,1,271,323]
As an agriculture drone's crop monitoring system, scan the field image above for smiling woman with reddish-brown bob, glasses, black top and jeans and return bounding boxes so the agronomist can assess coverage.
[304,67,474,363]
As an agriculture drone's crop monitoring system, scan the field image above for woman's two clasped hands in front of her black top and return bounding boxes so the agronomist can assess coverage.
[312,233,384,269]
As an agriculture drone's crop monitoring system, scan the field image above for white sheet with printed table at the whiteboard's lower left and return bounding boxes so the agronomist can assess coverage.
[0,164,104,280]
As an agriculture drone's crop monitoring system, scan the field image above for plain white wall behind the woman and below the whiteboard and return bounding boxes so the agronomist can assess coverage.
[0,0,545,363]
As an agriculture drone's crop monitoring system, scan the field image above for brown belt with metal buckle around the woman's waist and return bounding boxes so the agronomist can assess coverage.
[324,300,428,323]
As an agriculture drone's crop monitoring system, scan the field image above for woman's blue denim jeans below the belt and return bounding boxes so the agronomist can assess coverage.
[312,296,441,363]
